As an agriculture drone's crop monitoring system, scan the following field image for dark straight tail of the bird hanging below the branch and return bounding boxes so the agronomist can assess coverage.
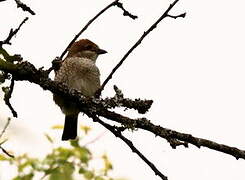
[62,114,78,141]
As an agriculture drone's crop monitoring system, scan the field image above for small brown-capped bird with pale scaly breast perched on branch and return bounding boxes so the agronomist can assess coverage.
[53,39,107,141]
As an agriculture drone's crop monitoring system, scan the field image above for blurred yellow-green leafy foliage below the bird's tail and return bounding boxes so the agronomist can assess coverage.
[0,128,122,180]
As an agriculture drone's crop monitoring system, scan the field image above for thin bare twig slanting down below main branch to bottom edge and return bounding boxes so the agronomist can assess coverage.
[92,115,168,180]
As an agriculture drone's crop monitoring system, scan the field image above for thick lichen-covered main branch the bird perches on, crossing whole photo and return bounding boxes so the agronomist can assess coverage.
[0,59,245,159]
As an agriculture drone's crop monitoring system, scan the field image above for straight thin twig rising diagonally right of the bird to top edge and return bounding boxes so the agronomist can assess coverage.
[97,0,185,94]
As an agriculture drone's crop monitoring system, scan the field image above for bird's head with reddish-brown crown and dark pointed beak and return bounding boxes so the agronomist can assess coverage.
[67,39,107,61]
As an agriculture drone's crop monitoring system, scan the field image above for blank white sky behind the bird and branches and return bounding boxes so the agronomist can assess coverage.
[0,0,245,180]
